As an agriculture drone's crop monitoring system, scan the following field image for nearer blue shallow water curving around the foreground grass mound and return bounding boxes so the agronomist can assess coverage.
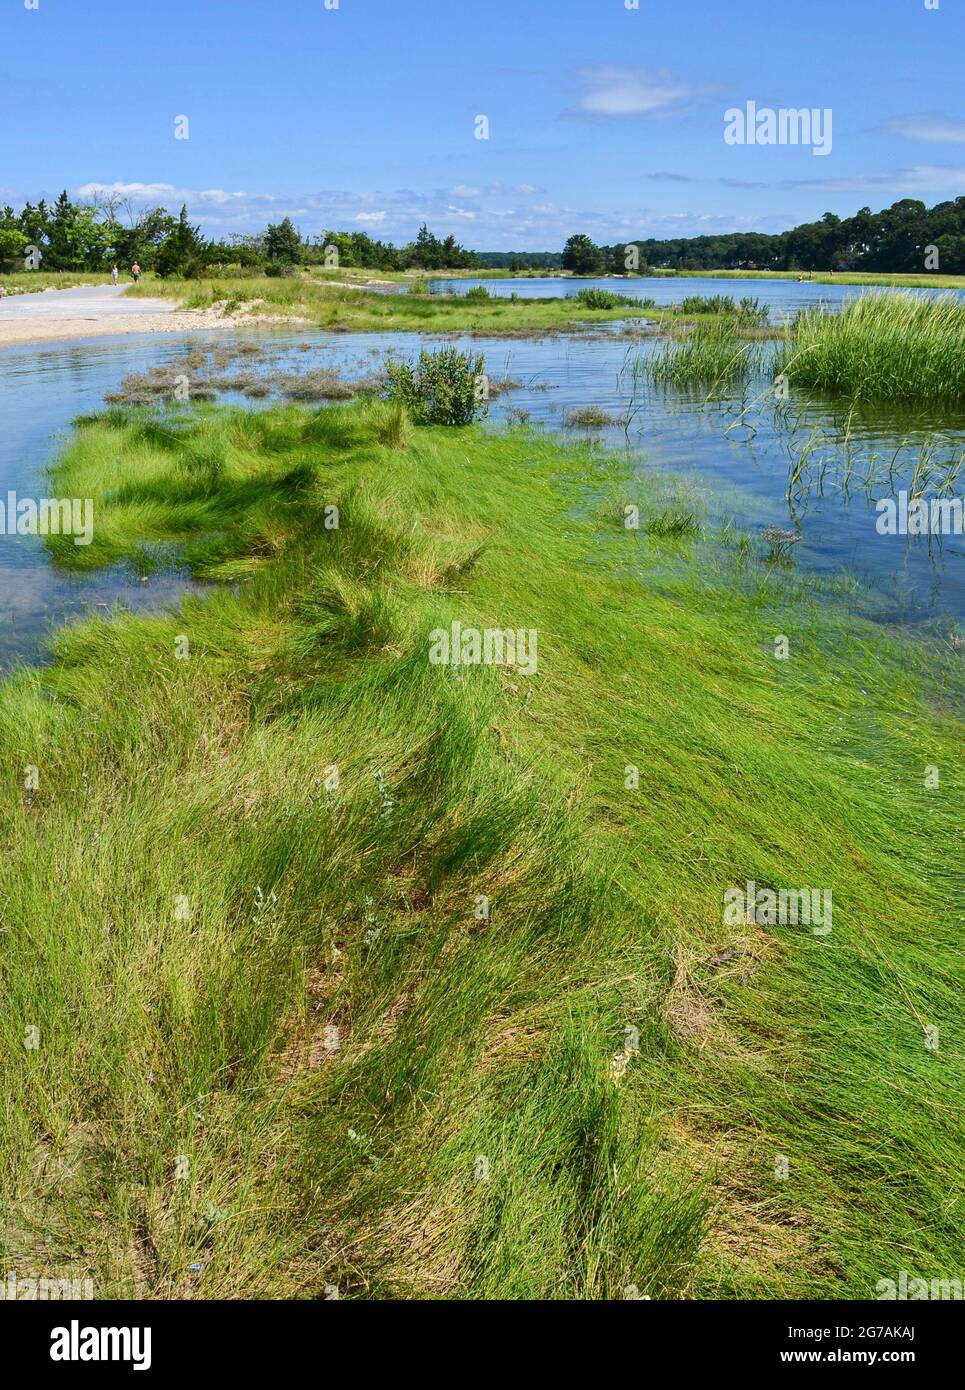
[0,312,965,671]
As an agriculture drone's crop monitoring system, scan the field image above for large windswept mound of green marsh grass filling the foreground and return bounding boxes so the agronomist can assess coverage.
[0,403,965,1300]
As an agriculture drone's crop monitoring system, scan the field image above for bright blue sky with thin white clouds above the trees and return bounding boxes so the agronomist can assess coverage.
[0,0,965,250]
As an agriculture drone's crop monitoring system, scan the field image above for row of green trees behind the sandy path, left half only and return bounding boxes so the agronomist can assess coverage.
[0,192,478,279]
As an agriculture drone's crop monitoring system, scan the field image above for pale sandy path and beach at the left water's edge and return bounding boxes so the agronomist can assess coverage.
[0,285,232,348]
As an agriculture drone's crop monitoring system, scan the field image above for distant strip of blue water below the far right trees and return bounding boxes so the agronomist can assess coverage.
[428,275,965,321]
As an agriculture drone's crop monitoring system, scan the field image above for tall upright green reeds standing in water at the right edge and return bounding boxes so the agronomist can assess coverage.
[777,295,965,403]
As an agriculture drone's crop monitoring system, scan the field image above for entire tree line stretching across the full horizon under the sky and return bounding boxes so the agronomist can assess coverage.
[7,192,965,278]
